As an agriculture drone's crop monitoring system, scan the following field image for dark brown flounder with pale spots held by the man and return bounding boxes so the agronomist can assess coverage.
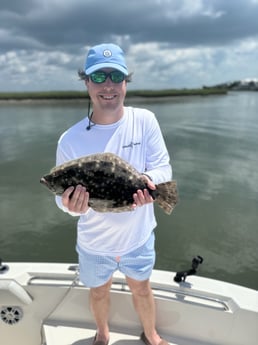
[40,153,177,214]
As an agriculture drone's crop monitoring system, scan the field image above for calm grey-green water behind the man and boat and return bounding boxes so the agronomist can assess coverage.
[0,92,258,289]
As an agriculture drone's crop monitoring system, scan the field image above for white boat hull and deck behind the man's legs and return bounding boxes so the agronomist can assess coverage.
[0,263,258,345]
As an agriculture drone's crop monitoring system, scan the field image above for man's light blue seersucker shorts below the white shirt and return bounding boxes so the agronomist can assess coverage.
[76,232,156,288]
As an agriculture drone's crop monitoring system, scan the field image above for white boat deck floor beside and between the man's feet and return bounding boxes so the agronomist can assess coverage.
[44,325,176,345]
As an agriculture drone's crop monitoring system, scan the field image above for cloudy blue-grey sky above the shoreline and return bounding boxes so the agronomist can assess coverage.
[0,0,258,91]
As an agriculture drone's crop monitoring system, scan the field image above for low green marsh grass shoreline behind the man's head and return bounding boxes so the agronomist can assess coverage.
[0,88,227,104]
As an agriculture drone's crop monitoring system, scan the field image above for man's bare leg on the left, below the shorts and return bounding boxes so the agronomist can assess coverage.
[90,278,112,344]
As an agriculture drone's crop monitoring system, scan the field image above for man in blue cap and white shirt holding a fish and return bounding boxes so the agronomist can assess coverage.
[56,44,172,345]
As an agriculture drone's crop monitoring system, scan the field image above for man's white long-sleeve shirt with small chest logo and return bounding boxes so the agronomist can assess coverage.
[56,107,172,256]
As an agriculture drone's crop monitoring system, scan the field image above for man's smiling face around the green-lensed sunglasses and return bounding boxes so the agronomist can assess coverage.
[85,68,126,110]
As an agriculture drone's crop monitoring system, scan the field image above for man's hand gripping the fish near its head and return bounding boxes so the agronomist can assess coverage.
[62,185,89,214]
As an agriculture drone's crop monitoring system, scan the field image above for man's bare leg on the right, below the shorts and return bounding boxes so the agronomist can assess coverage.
[126,277,164,345]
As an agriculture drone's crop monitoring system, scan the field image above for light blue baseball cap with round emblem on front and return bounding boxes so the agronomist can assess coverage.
[85,43,128,75]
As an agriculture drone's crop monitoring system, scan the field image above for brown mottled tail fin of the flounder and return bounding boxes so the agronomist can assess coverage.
[155,181,178,214]
